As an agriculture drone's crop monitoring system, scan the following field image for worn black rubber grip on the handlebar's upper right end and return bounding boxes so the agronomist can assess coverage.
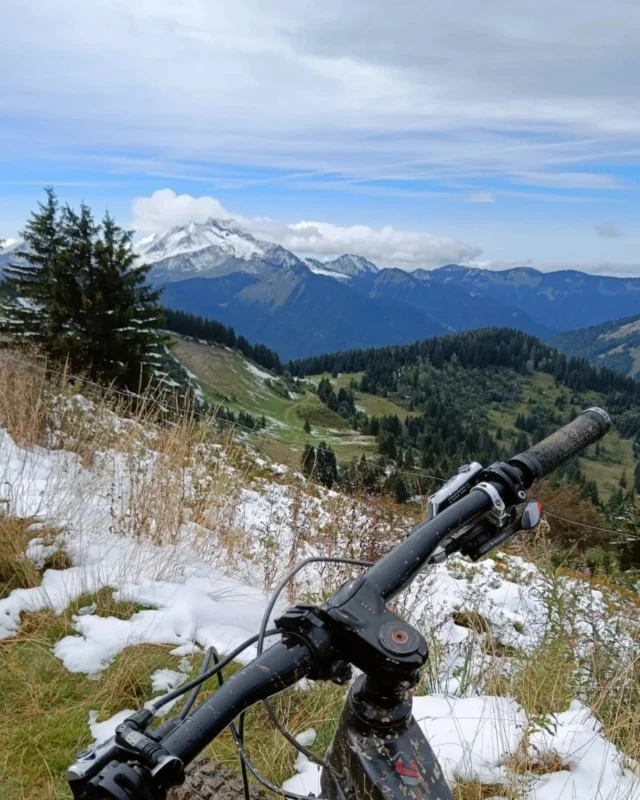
[509,408,611,488]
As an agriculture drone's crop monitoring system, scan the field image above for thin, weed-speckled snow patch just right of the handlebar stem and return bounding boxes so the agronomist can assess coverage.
[404,553,640,695]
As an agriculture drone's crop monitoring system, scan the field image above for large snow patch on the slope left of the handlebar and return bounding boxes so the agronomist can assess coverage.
[0,424,282,674]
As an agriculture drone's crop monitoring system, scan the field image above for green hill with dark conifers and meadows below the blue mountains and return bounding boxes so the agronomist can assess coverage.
[174,331,640,500]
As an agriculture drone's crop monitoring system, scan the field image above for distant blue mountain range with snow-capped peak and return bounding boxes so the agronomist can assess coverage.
[0,219,640,359]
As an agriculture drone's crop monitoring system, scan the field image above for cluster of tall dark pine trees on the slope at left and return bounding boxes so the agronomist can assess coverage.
[2,194,164,390]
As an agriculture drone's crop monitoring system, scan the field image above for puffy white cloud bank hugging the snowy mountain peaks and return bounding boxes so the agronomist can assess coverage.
[131,189,482,269]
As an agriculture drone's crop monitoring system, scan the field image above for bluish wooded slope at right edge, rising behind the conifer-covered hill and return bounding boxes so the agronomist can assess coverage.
[549,314,640,380]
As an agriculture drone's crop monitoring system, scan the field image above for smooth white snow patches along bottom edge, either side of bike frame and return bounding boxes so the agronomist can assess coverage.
[283,695,640,800]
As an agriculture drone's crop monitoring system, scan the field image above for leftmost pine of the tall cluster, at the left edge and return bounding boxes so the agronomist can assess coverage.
[2,187,62,345]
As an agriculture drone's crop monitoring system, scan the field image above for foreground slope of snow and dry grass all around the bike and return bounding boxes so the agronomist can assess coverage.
[0,358,640,800]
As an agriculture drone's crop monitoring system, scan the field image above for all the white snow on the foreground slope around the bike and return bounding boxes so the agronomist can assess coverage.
[0,400,640,800]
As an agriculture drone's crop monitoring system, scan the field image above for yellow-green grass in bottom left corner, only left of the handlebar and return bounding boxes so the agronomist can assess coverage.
[0,608,178,800]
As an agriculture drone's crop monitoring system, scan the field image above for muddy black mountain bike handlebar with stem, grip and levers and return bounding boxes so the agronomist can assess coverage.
[67,408,611,800]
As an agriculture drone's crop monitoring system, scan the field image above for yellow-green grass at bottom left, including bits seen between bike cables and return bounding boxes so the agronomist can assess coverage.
[0,592,344,800]
